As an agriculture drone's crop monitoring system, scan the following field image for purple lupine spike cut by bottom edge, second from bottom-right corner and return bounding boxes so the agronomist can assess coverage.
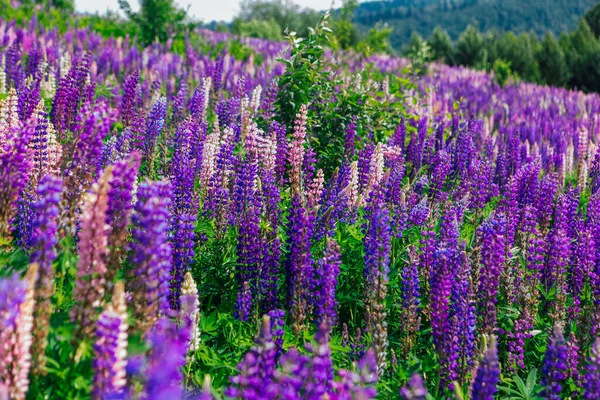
[541,325,568,400]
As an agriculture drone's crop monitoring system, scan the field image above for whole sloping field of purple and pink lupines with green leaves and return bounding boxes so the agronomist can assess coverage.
[0,16,600,400]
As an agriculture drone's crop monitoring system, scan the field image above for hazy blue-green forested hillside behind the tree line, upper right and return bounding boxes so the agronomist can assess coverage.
[355,0,598,48]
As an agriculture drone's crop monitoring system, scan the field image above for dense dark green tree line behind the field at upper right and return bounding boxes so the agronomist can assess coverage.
[418,3,600,92]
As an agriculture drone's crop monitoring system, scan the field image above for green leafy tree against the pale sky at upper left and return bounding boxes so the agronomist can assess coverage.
[118,0,186,45]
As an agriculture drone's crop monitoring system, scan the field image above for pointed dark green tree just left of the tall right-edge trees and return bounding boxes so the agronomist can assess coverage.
[536,32,569,86]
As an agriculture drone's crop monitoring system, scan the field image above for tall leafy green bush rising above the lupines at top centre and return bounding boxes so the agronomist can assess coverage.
[276,13,401,178]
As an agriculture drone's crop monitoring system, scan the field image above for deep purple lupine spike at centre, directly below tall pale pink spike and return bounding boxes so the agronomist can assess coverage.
[287,194,314,334]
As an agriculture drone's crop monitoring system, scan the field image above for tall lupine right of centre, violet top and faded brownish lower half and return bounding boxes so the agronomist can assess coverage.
[364,197,391,375]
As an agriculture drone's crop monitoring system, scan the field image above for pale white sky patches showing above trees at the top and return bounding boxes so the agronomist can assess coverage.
[75,0,332,22]
